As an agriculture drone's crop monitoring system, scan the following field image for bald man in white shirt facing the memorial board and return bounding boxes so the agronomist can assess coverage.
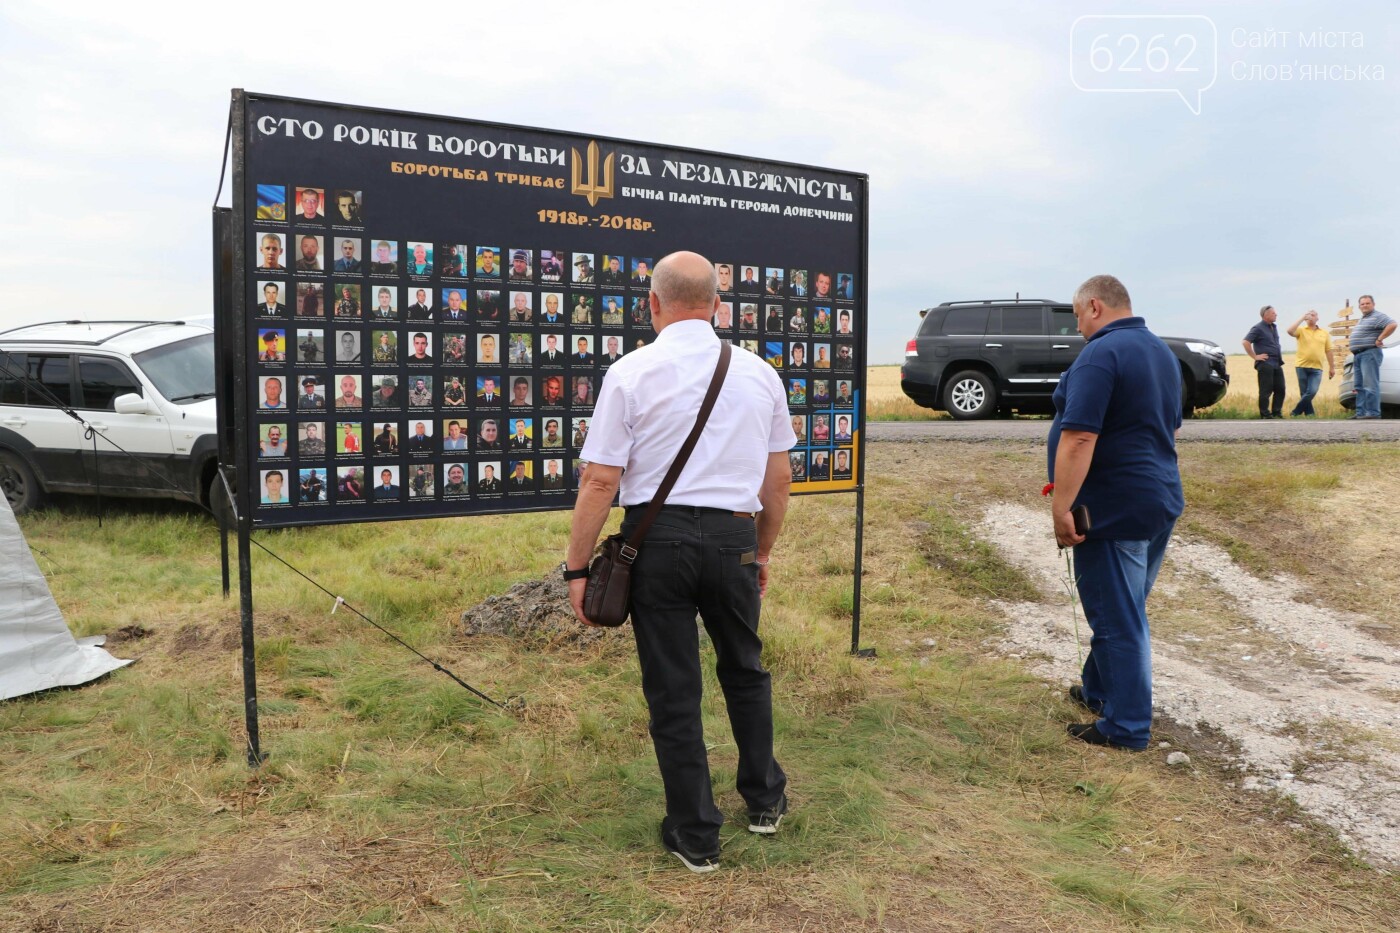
[564,252,797,871]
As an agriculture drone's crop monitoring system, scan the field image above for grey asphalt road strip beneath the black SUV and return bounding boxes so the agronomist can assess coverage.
[867,417,1400,444]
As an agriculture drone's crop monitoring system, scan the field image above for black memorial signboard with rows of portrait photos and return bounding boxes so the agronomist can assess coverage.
[229,94,867,527]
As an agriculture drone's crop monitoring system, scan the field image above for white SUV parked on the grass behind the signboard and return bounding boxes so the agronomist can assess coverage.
[0,321,218,513]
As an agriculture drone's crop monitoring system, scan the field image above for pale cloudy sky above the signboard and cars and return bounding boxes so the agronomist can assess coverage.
[0,0,1400,363]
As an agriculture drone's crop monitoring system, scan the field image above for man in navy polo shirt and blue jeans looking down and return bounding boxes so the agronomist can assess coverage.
[1049,276,1184,751]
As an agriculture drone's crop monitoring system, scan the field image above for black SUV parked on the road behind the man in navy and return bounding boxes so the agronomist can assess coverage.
[900,298,1229,420]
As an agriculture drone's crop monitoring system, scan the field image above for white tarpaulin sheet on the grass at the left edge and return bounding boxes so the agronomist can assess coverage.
[0,493,130,700]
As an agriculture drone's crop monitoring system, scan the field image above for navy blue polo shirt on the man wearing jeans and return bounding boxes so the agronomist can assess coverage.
[1047,318,1186,541]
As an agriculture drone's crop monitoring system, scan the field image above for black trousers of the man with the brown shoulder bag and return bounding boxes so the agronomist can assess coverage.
[622,506,787,853]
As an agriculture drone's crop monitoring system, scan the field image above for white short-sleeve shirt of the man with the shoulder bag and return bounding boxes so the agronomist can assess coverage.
[581,321,797,511]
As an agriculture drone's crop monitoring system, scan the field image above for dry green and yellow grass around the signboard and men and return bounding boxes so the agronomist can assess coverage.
[0,444,1400,932]
